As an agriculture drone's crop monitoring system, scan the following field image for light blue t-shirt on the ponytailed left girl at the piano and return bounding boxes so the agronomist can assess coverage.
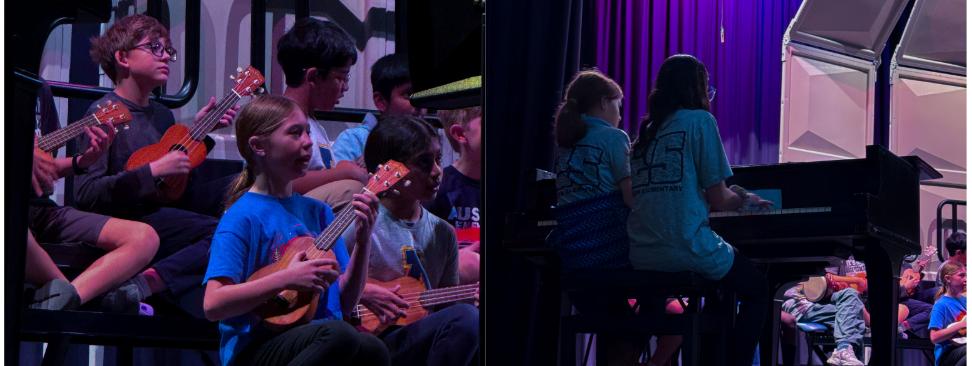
[556,116,631,206]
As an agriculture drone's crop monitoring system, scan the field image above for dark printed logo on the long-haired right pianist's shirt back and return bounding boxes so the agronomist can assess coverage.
[631,131,685,193]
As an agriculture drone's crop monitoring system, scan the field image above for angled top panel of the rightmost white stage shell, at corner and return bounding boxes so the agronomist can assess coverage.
[894,0,967,76]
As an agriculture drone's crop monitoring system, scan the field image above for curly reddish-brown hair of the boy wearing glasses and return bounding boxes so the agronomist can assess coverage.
[91,14,170,83]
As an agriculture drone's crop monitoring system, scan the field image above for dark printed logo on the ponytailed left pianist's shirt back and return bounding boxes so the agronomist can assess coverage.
[557,145,604,196]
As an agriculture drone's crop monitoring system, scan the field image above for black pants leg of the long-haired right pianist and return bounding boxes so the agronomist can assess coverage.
[706,248,770,366]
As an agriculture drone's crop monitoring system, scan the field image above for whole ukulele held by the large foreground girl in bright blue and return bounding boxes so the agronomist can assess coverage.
[247,160,409,332]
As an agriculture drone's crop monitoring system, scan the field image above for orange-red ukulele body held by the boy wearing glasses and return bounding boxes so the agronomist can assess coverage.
[125,125,207,203]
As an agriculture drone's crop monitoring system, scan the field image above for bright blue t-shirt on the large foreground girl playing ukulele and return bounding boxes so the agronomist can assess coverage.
[203,192,349,366]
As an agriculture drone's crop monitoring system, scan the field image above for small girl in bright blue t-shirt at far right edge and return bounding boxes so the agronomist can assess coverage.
[928,261,967,366]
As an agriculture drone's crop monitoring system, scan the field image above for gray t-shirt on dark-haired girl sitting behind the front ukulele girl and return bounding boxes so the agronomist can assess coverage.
[341,205,459,288]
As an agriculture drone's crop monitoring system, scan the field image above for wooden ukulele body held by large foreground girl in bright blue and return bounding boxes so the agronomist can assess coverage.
[247,236,340,332]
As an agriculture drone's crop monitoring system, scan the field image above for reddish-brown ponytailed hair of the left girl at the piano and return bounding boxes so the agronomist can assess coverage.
[554,69,624,147]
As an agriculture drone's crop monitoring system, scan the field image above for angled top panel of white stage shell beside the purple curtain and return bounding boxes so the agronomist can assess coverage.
[783,0,916,61]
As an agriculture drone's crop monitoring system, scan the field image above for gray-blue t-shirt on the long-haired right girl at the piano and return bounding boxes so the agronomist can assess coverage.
[628,109,733,280]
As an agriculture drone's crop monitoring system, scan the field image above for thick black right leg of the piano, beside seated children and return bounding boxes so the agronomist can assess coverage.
[862,240,906,365]
